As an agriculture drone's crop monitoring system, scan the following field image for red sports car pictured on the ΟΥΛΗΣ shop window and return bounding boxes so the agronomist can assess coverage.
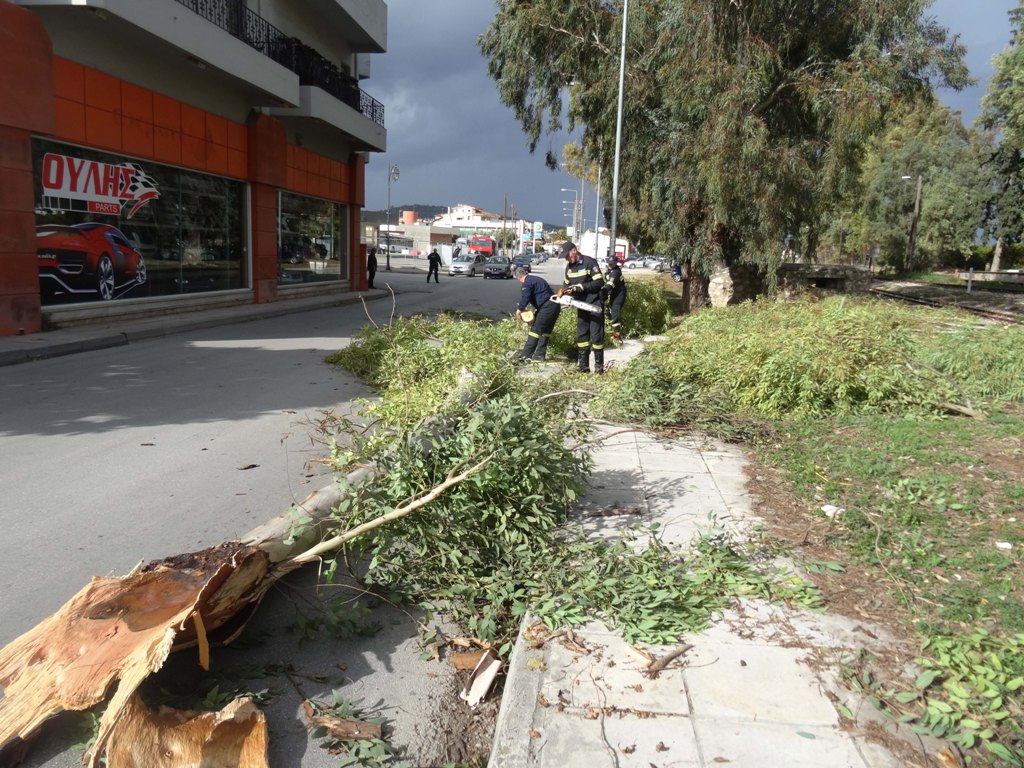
[36,221,146,301]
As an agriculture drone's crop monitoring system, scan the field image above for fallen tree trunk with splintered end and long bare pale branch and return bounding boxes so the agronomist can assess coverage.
[0,457,490,768]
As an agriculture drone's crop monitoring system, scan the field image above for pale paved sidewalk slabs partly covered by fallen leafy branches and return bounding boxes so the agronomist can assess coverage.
[489,421,908,768]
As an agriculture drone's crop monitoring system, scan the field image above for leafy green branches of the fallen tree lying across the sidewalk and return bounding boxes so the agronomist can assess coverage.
[328,313,817,653]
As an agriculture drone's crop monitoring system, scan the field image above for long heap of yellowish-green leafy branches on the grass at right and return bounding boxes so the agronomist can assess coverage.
[603,298,1024,419]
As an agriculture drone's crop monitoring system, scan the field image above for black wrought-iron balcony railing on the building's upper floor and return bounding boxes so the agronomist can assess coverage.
[177,0,384,125]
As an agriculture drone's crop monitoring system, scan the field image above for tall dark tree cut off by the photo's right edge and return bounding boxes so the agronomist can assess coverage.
[978,0,1024,269]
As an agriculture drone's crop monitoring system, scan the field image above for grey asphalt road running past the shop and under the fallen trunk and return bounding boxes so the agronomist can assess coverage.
[0,261,561,766]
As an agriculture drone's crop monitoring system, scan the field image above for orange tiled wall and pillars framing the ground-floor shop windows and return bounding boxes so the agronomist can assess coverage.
[0,29,366,335]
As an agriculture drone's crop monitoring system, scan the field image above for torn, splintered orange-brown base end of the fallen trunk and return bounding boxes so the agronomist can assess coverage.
[0,544,272,765]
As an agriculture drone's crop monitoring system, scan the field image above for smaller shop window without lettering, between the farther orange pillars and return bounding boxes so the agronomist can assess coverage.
[278,193,348,286]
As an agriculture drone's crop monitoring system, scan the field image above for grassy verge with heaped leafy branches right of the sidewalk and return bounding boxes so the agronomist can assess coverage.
[597,298,1024,765]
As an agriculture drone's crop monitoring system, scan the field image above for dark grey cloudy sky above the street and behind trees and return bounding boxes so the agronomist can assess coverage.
[362,0,1017,226]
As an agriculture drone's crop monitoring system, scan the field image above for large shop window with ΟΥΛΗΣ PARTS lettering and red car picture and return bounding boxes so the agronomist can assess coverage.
[33,139,248,305]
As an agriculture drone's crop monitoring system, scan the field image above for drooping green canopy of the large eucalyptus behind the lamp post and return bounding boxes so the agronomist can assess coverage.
[479,0,967,272]
